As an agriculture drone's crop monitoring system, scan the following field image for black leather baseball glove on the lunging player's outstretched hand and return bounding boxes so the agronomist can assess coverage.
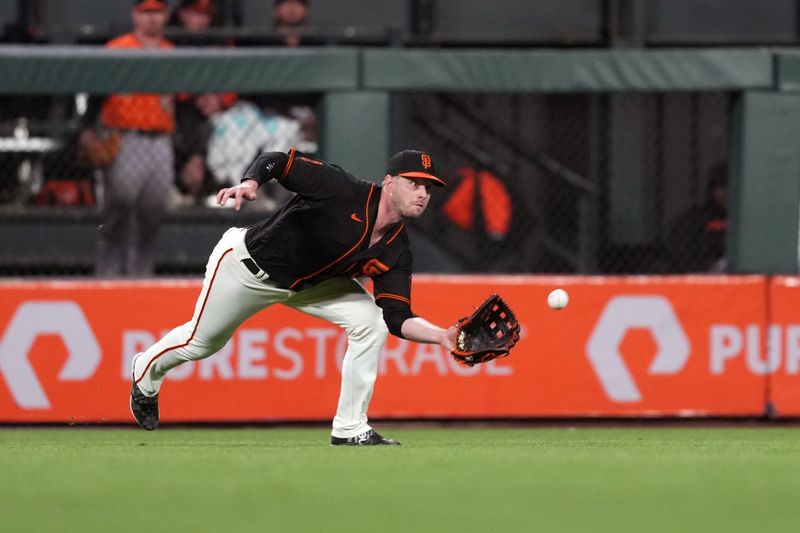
[451,294,519,366]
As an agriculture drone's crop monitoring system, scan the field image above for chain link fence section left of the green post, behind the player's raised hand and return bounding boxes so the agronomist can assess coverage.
[0,93,318,278]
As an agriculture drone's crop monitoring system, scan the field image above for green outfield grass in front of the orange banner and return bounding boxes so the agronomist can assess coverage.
[0,425,800,533]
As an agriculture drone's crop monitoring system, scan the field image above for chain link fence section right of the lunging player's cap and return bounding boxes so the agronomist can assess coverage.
[396,92,732,274]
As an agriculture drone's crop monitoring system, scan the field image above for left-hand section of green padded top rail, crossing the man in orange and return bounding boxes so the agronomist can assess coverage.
[0,46,358,95]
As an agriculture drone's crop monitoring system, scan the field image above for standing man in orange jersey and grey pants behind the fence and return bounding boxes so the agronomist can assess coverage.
[79,0,175,277]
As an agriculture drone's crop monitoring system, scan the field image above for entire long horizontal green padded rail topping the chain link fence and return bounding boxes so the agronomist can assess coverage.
[0,46,774,94]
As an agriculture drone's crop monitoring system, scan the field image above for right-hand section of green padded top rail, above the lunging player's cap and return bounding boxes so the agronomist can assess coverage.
[364,48,773,92]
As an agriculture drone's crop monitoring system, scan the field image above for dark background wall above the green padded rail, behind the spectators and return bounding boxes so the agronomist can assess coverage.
[9,0,798,46]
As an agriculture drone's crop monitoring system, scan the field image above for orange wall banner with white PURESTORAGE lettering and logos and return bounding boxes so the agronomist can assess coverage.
[0,275,800,423]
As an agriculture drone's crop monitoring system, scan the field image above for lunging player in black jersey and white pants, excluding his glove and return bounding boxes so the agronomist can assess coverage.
[130,150,455,445]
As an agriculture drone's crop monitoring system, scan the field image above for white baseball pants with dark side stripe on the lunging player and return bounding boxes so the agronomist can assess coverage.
[133,228,389,437]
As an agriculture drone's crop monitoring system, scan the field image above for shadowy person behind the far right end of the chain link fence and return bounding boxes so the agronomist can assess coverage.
[669,163,728,273]
